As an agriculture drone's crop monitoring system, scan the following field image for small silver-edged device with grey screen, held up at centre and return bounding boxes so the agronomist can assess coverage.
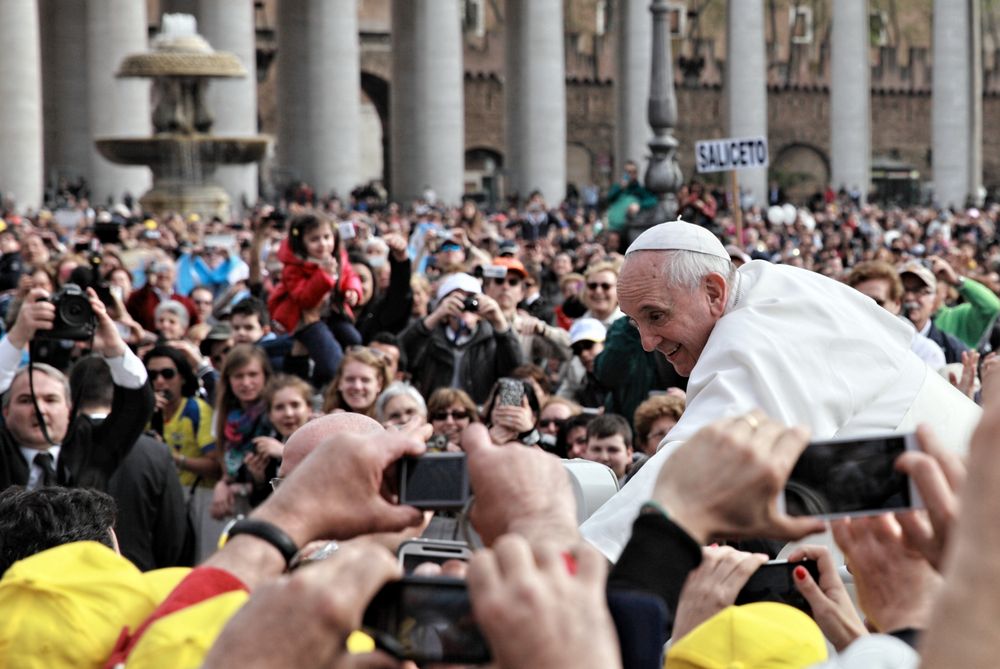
[399,453,472,511]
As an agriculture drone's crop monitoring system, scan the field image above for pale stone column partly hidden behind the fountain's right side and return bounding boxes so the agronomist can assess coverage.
[198,0,257,214]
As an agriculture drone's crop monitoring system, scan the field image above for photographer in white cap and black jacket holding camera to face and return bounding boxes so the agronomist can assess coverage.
[400,274,523,402]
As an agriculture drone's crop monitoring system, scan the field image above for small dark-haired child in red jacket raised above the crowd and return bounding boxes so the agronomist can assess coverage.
[267,214,361,348]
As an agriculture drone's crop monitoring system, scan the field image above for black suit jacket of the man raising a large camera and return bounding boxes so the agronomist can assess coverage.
[0,381,154,491]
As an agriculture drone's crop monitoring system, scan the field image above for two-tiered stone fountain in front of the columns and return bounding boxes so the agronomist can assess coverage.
[96,14,269,220]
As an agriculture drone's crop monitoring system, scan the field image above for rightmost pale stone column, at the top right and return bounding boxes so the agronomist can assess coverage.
[931,0,982,207]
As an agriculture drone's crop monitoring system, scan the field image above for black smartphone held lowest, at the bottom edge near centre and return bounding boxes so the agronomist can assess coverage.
[362,576,490,664]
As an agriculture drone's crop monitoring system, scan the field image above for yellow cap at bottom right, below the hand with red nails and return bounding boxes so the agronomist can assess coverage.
[664,602,827,669]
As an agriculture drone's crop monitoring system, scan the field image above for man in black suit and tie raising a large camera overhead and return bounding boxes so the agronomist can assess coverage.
[0,289,153,490]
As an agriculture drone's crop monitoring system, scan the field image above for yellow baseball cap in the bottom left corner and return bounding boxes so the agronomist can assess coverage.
[0,541,190,669]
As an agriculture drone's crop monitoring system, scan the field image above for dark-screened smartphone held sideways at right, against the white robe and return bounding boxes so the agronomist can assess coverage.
[778,434,923,518]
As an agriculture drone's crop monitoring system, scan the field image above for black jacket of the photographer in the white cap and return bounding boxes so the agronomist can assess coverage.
[400,319,524,404]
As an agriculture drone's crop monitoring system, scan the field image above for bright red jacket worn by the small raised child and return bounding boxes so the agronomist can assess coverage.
[267,239,361,332]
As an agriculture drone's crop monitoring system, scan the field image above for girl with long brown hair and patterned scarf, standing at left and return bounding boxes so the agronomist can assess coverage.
[212,344,273,518]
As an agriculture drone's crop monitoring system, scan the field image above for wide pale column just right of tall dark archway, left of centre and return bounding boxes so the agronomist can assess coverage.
[389,0,465,204]
